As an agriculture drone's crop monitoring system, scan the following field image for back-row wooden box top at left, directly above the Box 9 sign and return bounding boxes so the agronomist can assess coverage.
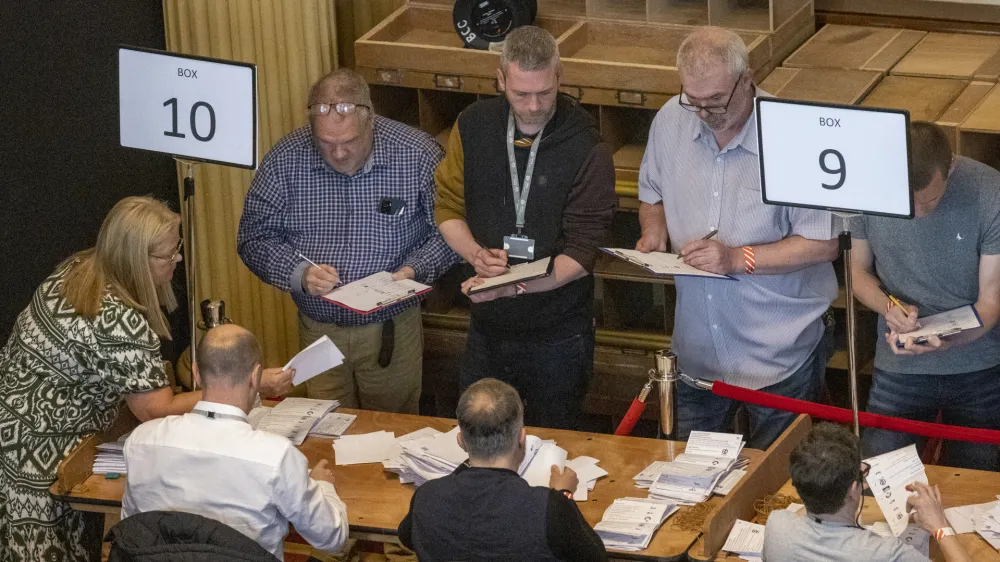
[782,25,927,73]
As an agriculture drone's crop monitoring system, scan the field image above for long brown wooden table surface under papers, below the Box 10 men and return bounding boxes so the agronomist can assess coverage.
[52,408,765,560]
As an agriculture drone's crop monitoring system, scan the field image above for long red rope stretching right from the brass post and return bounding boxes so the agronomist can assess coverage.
[712,381,1000,445]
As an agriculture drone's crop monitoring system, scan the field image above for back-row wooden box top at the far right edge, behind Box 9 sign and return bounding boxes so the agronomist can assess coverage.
[892,33,1000,81]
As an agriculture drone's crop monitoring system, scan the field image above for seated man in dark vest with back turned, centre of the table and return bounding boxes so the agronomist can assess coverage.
[399,379,607,562]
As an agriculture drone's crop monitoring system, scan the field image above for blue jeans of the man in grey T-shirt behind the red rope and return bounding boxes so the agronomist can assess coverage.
[861,366,1000,470]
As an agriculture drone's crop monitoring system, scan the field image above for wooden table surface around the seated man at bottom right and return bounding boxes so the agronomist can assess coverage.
[715,466,1000,562]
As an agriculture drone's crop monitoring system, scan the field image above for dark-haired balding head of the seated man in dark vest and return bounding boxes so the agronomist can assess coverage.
[456,379,524,460]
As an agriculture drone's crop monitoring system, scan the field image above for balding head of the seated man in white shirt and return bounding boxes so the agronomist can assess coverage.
[198,324,264,388]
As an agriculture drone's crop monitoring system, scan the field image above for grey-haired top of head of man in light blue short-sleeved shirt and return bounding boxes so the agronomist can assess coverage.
[677,26,749,81]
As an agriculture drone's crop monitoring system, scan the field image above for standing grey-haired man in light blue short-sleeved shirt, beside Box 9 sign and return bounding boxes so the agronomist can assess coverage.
[636,27,837,448]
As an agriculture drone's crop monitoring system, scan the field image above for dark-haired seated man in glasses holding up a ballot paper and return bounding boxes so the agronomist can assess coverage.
[763,423,971,562]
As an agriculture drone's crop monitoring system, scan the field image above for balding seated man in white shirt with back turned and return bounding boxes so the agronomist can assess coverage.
[122,324,348,560]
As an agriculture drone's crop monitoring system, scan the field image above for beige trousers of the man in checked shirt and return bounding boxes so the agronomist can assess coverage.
[299,306,424,414]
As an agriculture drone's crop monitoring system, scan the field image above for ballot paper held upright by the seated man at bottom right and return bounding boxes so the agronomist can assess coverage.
[865,445,927,537]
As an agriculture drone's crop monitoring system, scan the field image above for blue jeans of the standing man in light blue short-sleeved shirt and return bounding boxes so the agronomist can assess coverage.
[673,330,830,449]
